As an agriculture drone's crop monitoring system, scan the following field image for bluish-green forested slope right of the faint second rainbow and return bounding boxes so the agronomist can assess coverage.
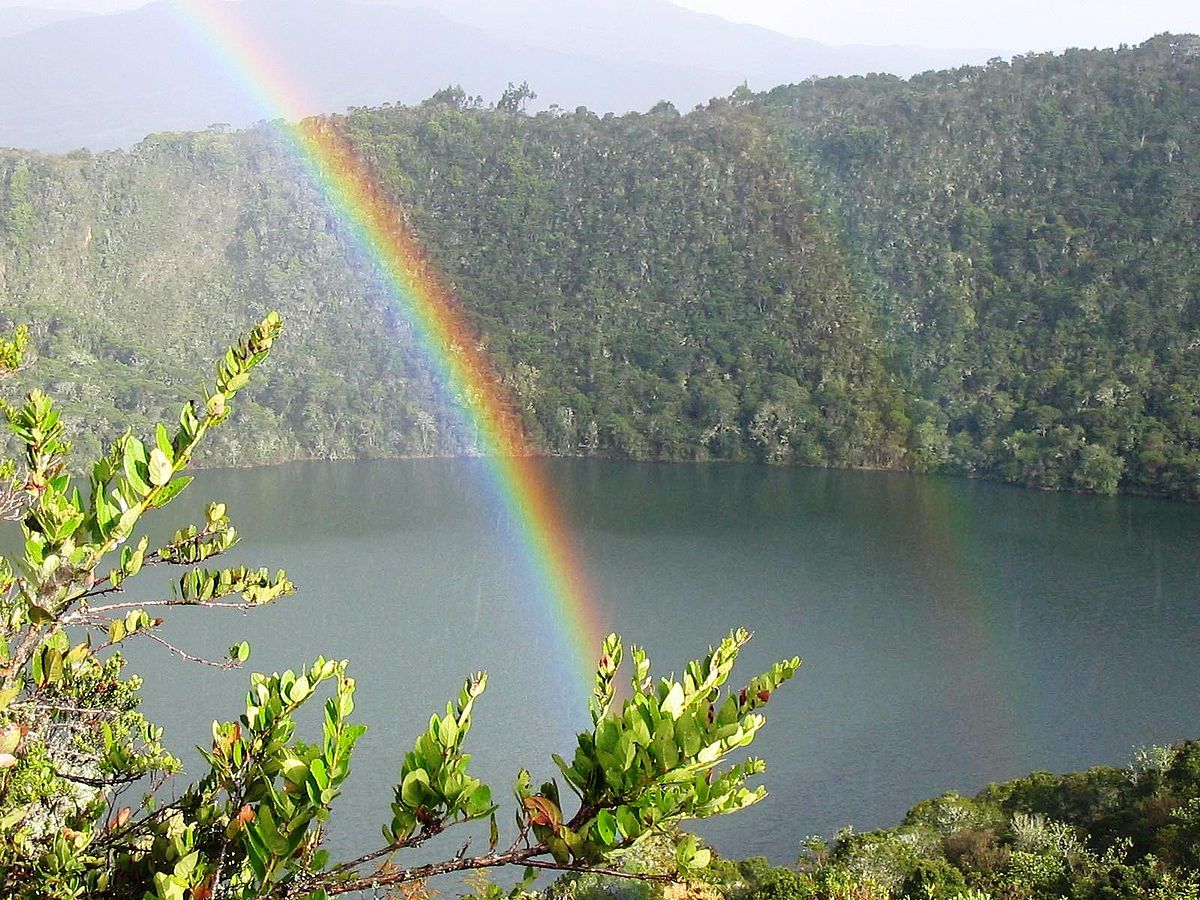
[764,36,1200,499]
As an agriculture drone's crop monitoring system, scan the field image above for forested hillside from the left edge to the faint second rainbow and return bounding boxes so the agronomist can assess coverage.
[0,94,904,466]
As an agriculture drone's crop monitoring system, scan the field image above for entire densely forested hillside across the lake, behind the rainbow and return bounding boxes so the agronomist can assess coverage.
[0,36,1200,499]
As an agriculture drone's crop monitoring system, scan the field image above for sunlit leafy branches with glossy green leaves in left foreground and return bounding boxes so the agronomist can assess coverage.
[0,313,799,900]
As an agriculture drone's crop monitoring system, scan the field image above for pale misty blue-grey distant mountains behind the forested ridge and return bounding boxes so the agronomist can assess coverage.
[0,0,992,152]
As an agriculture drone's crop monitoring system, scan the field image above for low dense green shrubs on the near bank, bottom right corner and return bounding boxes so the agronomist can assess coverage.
[561,740,1200,900]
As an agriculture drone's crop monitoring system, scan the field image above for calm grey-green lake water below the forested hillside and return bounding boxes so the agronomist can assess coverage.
[119,461,1200,862]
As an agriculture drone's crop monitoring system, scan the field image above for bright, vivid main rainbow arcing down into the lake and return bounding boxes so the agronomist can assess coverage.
[173,0,605,691]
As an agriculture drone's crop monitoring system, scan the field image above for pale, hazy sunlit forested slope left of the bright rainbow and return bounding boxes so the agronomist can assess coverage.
[0,131,460,464]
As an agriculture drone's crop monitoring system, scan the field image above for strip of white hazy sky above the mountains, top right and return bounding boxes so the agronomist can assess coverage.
[673,0,1200,53]
